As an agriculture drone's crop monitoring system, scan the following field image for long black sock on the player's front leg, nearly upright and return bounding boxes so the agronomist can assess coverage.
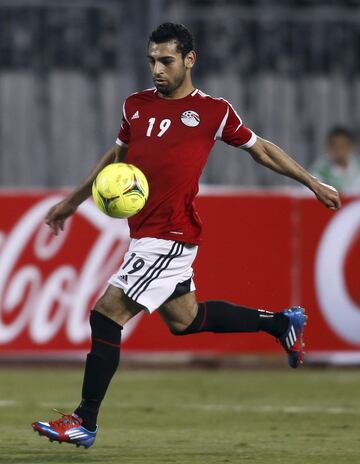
[74,310,122,430]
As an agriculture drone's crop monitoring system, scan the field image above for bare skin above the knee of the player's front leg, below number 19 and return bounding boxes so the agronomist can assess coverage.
[94,285,144,325]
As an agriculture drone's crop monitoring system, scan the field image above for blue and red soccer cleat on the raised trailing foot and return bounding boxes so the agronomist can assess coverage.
[278,306,307,369]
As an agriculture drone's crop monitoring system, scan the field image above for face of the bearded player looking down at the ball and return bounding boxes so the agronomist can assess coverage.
[148,40,192,96]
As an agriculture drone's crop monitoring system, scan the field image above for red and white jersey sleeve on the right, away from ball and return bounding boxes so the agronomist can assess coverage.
[215,101,256,148]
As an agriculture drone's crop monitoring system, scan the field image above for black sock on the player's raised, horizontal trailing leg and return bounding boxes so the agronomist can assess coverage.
[177,301,289,337]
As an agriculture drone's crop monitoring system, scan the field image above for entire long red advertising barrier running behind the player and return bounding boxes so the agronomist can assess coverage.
[0,189,360,363]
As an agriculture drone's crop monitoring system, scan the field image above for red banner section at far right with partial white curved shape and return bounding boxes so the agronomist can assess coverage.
[297,198,360,361]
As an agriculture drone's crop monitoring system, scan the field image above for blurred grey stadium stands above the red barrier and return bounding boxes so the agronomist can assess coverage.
[0,0,360,187]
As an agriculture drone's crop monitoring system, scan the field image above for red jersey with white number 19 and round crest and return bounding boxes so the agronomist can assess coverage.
[116,88,256,244]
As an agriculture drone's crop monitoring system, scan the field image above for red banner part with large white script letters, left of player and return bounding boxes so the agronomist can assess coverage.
[0,194,129,352]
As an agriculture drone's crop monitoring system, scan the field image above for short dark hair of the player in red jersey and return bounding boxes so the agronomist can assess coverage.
[149,23,194,58]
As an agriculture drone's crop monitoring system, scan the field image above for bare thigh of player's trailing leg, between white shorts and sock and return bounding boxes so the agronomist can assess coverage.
[159,292,198,333]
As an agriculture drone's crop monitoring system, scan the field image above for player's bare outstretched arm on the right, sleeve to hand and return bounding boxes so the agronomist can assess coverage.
[245,137,341,210]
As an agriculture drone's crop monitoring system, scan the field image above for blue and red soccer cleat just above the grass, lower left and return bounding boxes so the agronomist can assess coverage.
[31,409,98,448]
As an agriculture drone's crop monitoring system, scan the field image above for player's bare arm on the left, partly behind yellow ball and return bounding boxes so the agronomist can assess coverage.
[45,144,127,235]
